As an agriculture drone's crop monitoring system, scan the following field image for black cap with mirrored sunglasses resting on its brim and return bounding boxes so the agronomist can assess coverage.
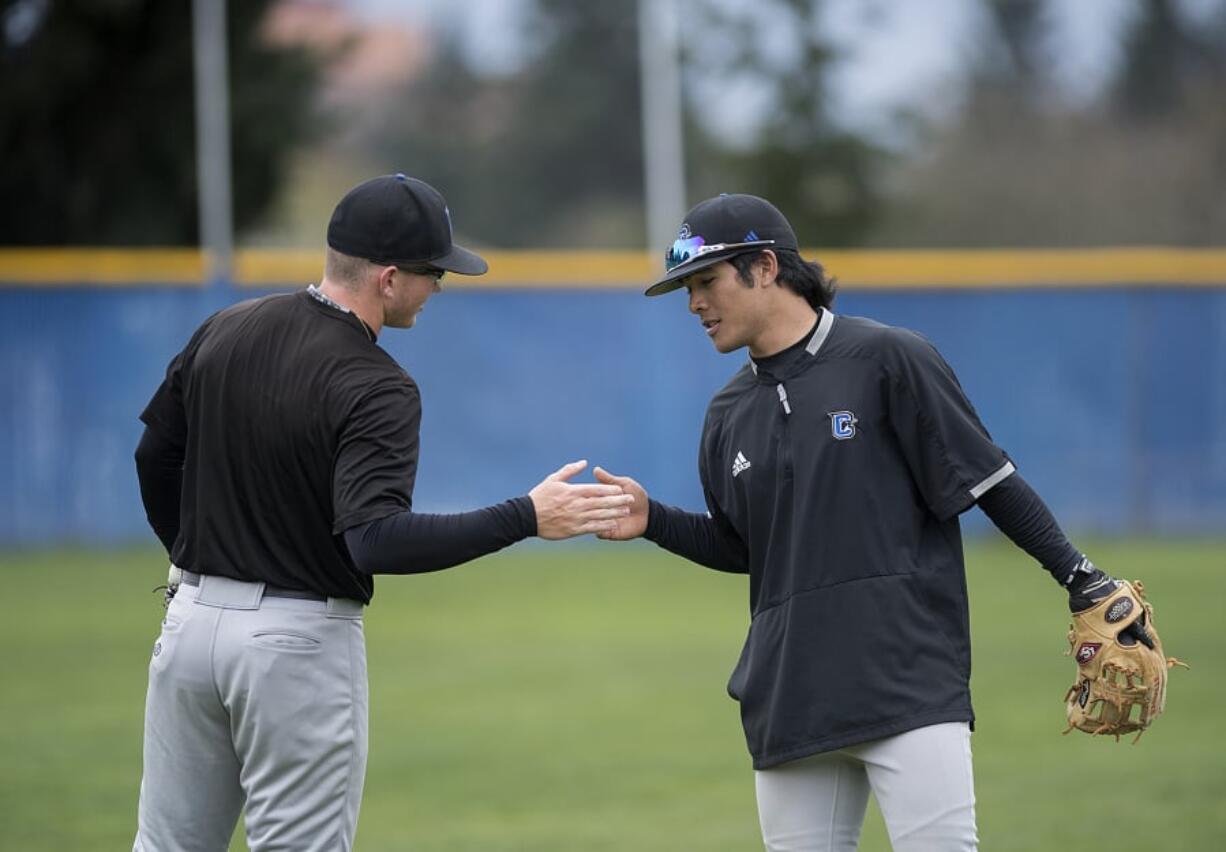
[646,194,801,295]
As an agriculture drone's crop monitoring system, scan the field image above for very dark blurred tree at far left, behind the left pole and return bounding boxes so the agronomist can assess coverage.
[0,0,321,245]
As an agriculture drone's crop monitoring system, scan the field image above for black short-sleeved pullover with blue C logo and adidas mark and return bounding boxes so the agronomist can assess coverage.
[649,311,1013,769]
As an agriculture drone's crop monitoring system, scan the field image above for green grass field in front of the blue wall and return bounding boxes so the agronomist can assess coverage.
[0,541,1226,852]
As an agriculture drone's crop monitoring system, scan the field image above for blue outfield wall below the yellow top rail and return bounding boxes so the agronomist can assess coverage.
[0,286,1226,547]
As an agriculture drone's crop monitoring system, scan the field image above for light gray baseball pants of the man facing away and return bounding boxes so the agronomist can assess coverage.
[134,576,368,852]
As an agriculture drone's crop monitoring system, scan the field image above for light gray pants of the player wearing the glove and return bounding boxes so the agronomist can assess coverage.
[754,722,978,852]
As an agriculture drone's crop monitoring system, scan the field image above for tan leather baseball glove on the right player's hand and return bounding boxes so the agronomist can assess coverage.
[1064,580,1187,742]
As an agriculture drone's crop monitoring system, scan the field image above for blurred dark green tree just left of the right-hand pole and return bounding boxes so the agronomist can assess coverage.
[373,0,644,248]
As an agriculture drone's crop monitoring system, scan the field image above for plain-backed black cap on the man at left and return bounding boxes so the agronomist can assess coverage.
[327,174,489,275]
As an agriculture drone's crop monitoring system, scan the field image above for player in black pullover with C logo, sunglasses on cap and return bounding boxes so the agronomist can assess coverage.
[596,195,1127,852]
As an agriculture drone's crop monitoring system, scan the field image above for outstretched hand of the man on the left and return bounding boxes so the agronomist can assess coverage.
[528,461,634,541]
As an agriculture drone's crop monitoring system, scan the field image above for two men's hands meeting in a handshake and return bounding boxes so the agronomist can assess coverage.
[528,461,647,541]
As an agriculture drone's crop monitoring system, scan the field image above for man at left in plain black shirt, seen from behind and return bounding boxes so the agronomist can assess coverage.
[135,174,633,852]
